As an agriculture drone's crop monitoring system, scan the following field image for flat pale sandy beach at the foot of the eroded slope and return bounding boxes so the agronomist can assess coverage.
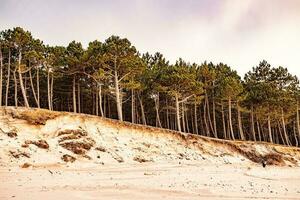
[0,161,300,200]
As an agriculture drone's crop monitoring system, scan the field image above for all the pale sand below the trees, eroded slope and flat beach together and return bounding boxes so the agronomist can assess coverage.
[0,108,300,199]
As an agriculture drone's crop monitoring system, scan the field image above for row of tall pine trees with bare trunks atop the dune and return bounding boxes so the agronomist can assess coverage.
[0,27,300,146]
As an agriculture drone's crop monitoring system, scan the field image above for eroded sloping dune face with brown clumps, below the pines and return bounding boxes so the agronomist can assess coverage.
[0,108,300,167]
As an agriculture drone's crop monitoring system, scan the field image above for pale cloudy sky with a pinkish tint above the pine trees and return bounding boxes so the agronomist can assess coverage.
[0,0,300,78]
